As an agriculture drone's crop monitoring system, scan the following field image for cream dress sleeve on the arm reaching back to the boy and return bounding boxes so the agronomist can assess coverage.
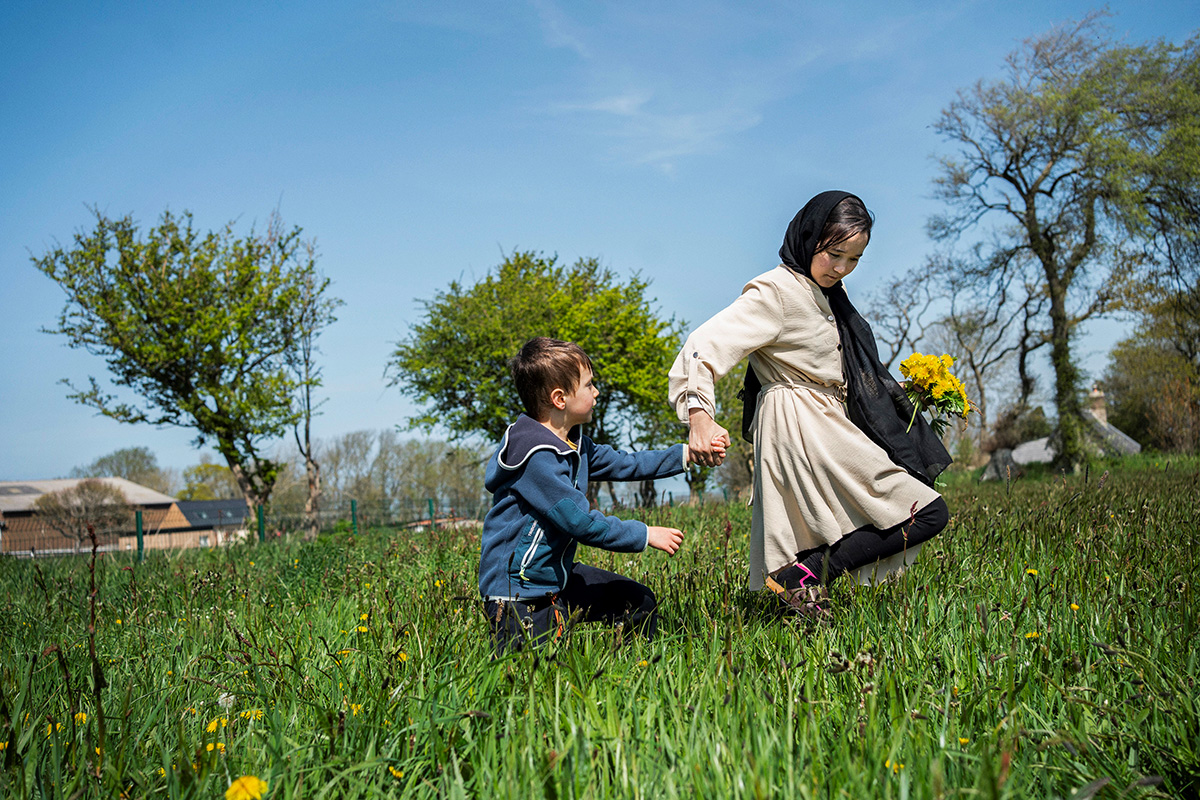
[668,279,784,422]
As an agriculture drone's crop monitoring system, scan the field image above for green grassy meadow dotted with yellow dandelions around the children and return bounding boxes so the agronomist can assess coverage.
[0,456,1200,799]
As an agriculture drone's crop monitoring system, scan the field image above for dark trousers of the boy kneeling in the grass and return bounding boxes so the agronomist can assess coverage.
[484,564,659,655]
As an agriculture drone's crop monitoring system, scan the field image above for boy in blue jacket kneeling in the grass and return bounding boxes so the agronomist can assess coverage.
[479,337,715,654]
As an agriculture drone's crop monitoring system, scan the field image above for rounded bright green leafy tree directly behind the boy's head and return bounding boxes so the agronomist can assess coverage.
[388,252,682,460]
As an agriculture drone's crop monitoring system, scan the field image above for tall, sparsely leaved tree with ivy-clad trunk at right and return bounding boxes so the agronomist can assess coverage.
[930,14,1200,469]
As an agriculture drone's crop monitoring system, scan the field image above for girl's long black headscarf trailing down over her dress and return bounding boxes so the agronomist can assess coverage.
[742,192,953,486]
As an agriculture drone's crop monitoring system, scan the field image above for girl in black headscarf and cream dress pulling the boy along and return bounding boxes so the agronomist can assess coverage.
[670,192,950,613]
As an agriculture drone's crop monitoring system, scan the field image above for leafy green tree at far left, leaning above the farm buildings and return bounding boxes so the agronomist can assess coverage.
[34,210,332,506]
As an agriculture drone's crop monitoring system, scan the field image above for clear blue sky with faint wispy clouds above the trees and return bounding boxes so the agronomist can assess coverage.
[0,0,1200,480]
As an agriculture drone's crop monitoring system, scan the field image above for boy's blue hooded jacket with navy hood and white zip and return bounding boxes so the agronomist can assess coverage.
[479,414,686,600]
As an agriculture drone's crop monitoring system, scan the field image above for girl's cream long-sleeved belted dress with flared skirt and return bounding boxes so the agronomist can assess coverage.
[670,265,938,589]
